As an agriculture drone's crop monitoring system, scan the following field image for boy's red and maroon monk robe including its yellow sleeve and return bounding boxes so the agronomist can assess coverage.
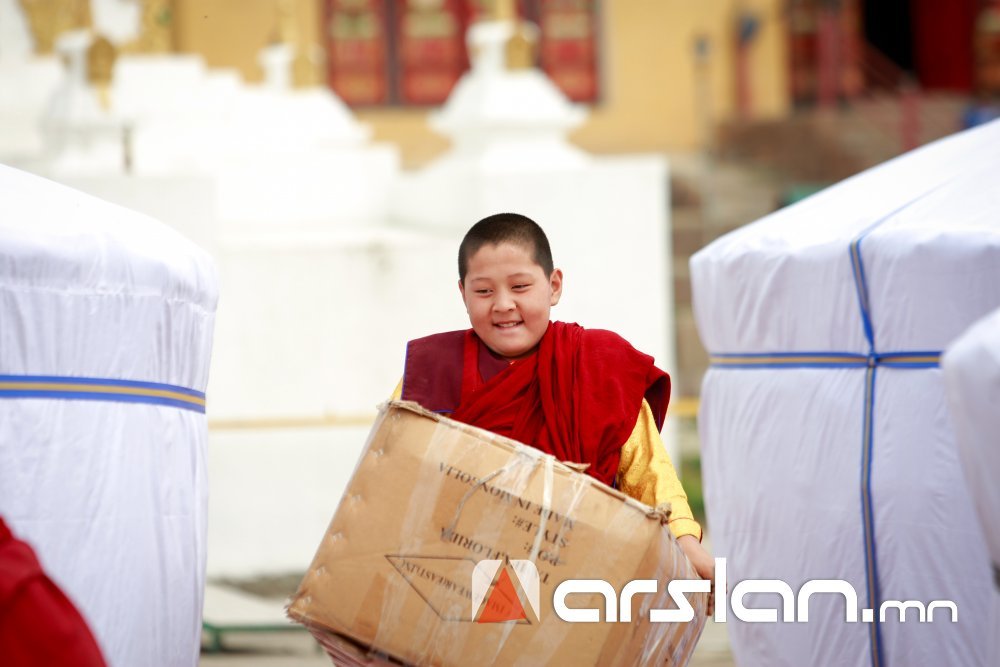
[397,322,701,539]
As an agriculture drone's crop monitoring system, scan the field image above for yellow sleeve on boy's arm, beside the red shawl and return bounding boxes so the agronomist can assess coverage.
[618,399,701,541]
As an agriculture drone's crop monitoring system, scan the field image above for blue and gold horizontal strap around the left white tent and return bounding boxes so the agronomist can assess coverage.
[0,375,205,414]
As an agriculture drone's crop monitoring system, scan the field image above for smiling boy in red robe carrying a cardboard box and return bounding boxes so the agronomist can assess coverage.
[394,213,715,579]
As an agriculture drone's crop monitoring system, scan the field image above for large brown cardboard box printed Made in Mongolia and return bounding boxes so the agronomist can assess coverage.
[288,402,708,665]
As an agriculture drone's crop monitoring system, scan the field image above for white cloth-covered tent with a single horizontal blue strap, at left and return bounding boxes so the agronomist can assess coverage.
[0,167,217,667]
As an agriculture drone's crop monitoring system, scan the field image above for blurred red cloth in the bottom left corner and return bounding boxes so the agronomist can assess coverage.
[0,519,104,667]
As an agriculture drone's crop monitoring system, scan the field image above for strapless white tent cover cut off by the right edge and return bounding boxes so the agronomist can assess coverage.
[941,310,1000,665]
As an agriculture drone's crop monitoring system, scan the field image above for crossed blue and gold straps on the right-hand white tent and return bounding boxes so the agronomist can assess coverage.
[710,219,941,667]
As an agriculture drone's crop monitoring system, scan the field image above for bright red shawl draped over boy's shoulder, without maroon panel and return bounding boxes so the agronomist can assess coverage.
[452,322,670,485]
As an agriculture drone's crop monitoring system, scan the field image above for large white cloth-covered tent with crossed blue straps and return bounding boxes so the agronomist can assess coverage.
[691,123,1000,666]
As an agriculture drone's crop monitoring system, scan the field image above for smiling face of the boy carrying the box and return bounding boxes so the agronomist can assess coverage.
[458,243,562,359]
